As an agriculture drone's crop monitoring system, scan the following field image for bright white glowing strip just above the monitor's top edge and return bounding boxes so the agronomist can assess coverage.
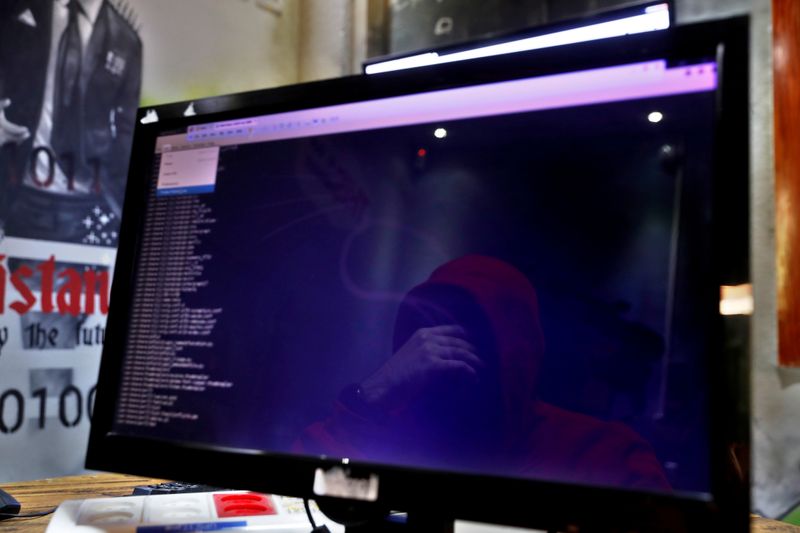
[365,4,669,74]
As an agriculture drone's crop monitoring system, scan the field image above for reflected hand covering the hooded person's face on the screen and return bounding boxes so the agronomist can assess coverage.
[361,325,484,410]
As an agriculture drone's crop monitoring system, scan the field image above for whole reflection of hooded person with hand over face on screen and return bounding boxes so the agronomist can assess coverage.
[297,256,669,490]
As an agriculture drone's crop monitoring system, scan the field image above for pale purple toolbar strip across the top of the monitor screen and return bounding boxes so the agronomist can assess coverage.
[156,60,717,152]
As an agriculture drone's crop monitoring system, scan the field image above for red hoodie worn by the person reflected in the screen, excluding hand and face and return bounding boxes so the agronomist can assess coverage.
[295,256,670,490]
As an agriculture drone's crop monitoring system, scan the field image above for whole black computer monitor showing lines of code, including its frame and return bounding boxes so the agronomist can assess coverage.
[87,19,748,531]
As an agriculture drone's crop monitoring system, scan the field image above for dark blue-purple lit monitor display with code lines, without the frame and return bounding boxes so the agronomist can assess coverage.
[114,61,716,491]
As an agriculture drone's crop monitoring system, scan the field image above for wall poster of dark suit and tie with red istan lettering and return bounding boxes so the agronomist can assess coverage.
[0,0,142,477]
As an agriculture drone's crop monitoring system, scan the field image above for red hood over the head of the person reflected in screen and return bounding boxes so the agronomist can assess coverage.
[394,255,544,447]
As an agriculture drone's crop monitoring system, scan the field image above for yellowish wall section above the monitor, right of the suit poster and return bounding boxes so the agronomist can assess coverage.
[135,0,303,105]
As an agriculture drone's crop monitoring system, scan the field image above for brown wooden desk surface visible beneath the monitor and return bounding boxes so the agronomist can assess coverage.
[0,472,800,533]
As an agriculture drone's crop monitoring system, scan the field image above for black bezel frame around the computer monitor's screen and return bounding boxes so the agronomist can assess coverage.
[86,17,749,532]
